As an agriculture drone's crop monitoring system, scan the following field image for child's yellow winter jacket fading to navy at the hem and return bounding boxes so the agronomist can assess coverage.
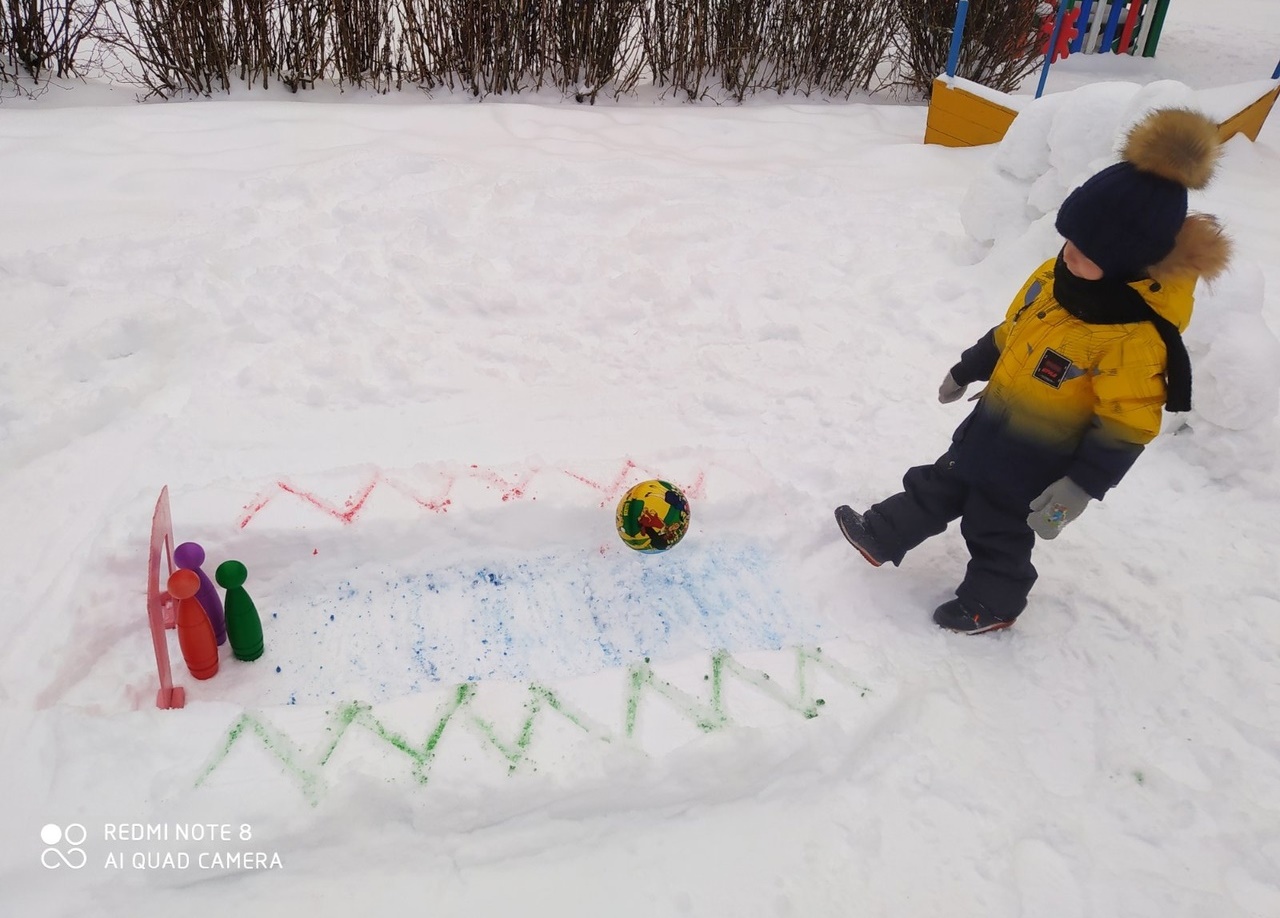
[951,260,1196,506]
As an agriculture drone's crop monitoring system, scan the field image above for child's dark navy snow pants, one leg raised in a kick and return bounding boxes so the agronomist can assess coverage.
[864,453,1036,618]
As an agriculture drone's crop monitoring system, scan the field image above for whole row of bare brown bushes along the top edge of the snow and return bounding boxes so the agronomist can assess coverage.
[12,0,1039,102]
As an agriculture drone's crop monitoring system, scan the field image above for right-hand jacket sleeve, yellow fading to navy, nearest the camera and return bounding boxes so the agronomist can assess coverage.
[1068,325,1165,501]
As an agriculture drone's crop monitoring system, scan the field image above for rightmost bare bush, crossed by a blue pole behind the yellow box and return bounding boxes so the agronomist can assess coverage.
[895,0,1043,99]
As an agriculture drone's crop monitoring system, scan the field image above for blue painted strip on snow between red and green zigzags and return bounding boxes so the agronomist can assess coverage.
[282,543,819,699]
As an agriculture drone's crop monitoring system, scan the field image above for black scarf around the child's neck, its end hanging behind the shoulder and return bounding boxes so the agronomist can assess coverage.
[1053,252,1192,411]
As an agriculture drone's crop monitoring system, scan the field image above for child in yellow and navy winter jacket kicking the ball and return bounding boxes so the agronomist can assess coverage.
[836,109,1230,634]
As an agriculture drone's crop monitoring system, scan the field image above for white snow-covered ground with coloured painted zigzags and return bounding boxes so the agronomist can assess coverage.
[0,0,1280,918]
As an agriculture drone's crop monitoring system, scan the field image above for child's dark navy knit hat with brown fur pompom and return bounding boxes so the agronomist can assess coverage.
[1056,109,1221,280]
